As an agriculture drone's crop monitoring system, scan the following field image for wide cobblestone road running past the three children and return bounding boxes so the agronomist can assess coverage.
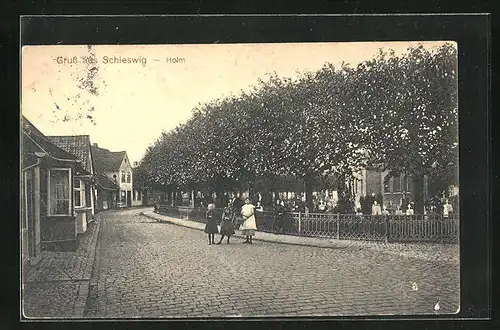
[85,210,459,318]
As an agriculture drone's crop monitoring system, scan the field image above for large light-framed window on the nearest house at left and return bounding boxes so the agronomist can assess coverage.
[48,169,71,215]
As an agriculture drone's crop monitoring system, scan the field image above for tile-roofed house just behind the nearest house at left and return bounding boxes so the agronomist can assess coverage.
[48,135,96,234]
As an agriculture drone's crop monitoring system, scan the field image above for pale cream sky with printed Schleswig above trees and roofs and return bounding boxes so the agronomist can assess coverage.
[21,42,450,162]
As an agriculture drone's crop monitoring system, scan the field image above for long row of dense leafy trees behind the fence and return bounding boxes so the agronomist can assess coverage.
[136,44,458,211]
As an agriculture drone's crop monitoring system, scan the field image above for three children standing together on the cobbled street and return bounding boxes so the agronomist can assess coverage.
[205,198,257,245]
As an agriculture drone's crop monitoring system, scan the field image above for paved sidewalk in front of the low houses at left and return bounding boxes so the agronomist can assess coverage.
[23,217,100,319]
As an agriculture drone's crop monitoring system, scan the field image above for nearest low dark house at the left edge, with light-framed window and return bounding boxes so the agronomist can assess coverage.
[21,116,91,264]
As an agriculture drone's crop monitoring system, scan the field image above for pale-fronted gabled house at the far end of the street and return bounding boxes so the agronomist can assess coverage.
[92,143,133,210]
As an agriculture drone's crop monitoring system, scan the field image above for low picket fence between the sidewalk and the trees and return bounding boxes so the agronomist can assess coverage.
[155,205,459,243]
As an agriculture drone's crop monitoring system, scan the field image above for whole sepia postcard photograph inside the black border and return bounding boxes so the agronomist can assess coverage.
[20,40,460,320]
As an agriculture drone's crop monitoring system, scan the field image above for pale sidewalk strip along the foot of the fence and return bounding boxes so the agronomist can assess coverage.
[141,211,460,264]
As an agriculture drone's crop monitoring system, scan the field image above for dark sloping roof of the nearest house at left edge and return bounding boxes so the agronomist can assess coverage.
[21,116,78,167]
